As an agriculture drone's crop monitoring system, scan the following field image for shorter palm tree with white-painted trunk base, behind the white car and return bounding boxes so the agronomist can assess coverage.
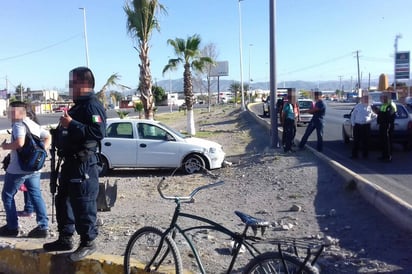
[163,34,213,135]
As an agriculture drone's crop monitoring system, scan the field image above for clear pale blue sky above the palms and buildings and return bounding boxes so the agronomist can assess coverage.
[0,0,412,91]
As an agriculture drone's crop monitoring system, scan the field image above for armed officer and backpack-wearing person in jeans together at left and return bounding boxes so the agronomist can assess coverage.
[0,67,106,261]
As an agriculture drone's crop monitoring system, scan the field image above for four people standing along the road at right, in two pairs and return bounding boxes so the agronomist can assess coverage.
[281,92,397,162]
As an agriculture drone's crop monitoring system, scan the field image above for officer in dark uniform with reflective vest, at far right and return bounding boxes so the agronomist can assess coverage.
[377,93,397,162]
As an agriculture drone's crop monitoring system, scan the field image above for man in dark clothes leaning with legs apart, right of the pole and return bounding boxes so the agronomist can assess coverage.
[299,91,326,152]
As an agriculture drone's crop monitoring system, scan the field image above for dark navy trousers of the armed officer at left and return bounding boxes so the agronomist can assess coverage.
[56,157,99,243]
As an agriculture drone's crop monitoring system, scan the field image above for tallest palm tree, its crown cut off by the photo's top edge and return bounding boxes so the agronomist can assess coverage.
[123,0,166,120]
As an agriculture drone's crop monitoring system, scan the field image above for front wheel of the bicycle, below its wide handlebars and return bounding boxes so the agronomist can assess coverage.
[123,226,183,274]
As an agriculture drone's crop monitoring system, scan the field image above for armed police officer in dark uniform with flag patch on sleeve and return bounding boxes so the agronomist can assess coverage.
[43,67,106,261]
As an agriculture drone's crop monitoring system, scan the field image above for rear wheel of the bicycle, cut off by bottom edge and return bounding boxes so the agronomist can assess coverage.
[243,252,319,274]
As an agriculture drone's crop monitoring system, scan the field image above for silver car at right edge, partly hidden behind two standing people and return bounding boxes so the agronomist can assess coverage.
[342,102,412,150]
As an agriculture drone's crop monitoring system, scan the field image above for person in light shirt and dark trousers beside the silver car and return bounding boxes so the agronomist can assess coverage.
[350,95,377,159]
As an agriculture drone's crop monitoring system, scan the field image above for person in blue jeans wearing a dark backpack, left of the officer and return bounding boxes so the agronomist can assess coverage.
[0,101,51,238]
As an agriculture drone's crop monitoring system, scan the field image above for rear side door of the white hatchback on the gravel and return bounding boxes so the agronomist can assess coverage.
[102,122,138,167]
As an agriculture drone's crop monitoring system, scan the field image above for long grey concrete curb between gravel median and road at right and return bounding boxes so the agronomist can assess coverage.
[249,105,412,232]
